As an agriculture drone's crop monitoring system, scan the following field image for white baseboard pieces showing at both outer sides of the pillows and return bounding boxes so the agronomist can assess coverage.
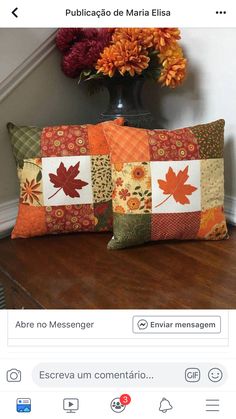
[0,195,236,238]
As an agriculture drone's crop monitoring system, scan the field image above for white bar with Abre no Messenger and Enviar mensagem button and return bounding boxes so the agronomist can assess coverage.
[8,310,228,346]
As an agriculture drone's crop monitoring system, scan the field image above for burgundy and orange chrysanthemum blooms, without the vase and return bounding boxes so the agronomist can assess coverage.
[56,28,187,88]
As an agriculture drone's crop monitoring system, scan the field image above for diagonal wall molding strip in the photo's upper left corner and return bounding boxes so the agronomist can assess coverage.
[0,29,56,102]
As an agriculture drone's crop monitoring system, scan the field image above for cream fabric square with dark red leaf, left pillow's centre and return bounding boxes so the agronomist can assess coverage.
[42,156,93,206]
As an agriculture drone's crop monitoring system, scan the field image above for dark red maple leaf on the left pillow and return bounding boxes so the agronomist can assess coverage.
[48,162,88,199]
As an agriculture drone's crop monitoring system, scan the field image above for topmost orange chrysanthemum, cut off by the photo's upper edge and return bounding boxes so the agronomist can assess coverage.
[112,28,153,48]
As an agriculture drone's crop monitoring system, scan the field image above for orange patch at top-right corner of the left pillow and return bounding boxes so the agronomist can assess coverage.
[88,118,124,156]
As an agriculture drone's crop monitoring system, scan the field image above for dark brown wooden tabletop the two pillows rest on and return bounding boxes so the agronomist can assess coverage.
[0,228,236,309]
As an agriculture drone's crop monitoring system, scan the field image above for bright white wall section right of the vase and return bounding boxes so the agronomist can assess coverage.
[145,28,236,201]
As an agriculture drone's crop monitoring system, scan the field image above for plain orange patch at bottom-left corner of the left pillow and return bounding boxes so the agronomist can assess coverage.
[11,204,48,239]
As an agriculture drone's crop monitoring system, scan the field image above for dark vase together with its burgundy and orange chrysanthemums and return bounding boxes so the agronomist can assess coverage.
[56,28,187,128]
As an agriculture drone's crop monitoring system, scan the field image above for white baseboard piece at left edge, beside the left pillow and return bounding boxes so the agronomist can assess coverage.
[0,199,18,238]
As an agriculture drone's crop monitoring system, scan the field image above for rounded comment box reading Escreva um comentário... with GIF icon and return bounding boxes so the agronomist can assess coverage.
[32,362,227,389]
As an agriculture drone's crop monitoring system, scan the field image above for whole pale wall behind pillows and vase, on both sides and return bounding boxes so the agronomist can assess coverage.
[0,29,236,235]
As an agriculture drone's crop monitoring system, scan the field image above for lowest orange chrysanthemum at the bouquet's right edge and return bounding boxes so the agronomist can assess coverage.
[159,57,187,88]
